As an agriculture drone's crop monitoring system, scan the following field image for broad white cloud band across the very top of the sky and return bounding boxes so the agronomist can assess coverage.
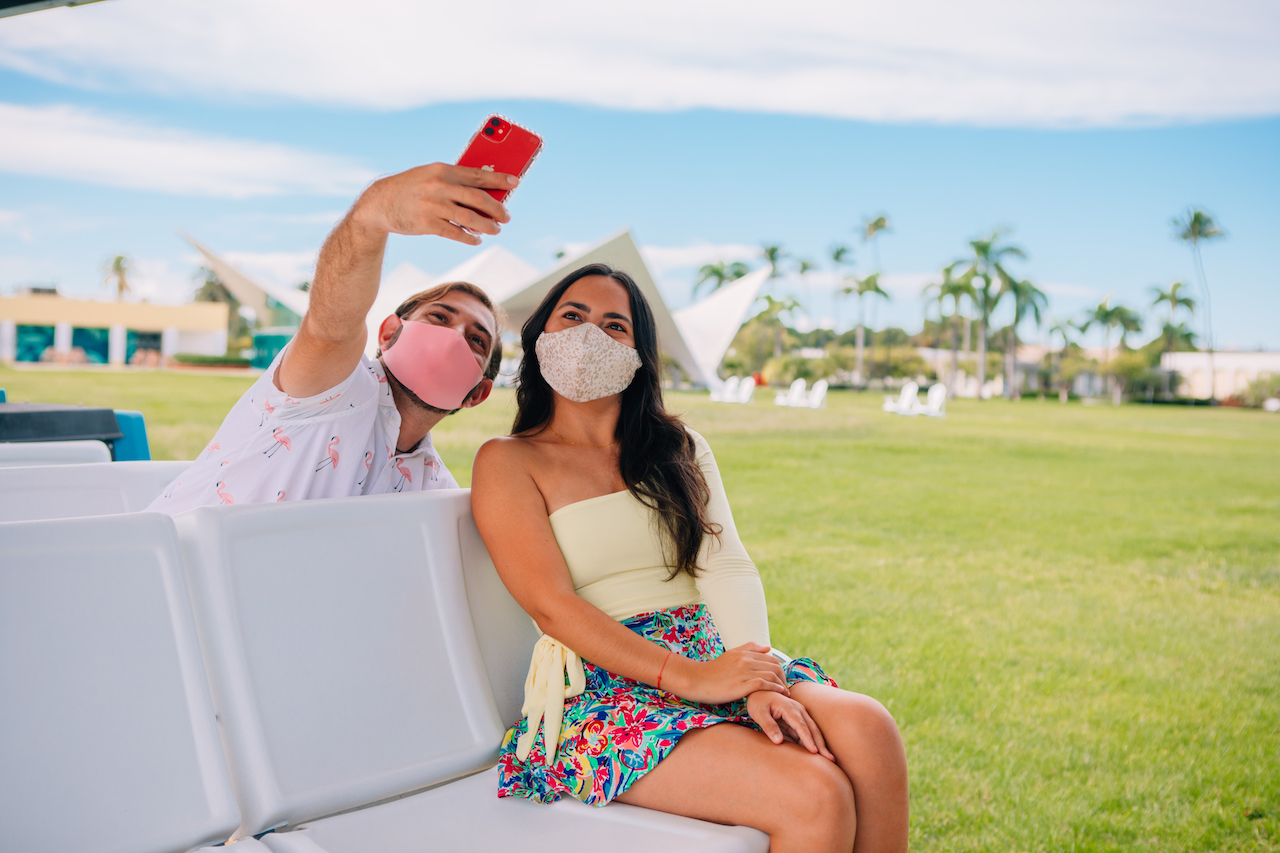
[0,0,1280,126]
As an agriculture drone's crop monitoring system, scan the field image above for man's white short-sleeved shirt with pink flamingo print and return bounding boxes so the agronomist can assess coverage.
[147,350,458,515]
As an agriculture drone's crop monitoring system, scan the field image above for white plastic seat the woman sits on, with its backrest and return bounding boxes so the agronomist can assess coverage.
[174,491,768,853]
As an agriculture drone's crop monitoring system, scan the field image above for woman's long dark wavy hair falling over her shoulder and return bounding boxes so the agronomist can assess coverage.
[511,264,719,578]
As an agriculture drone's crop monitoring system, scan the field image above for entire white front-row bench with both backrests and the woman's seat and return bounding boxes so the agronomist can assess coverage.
[0,491,768,853]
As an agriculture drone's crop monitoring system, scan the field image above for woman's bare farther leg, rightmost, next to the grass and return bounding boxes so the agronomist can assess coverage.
[791,681,909,853]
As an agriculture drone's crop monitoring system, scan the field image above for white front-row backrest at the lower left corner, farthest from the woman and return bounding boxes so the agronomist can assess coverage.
[0,512,239,853]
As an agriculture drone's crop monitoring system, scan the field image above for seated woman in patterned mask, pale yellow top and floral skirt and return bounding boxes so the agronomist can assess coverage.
[471,264,908,853]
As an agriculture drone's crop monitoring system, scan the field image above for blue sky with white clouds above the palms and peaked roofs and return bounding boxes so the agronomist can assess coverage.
[0,0,1280,348]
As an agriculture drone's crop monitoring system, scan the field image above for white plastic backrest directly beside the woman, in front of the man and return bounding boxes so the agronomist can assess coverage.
[174,491,536,838]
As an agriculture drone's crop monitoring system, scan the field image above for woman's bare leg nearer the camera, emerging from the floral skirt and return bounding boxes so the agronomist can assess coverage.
[618,722,856,853]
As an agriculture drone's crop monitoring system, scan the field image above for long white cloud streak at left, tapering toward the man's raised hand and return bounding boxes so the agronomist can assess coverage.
[0,102,376,199]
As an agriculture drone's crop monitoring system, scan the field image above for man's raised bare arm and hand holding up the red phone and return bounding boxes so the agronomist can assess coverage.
[275,163,517,397]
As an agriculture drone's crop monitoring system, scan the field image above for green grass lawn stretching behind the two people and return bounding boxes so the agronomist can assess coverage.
[0,361,1280,850]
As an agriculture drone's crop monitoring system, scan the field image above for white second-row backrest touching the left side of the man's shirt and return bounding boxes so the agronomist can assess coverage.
[0,458,191,521]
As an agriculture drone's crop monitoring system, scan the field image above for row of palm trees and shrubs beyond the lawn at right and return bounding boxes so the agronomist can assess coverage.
[694,207,1225,400]
